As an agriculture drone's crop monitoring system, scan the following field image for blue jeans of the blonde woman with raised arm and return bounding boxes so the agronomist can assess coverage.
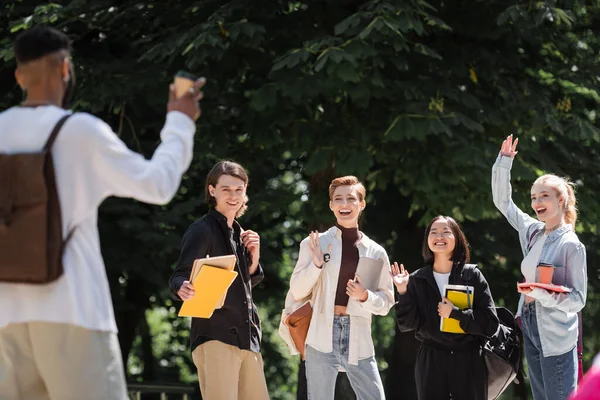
[521,301,577,400]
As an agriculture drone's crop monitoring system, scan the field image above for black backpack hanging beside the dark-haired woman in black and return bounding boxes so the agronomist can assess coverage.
[462,264,521,400]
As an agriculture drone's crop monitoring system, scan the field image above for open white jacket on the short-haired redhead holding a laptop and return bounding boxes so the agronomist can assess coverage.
[279,226,394,365]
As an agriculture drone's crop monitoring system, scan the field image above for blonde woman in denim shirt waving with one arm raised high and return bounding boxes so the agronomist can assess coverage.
[492,135,587,400]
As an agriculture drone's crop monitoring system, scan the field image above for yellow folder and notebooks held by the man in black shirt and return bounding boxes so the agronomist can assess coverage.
[178,255,238,318]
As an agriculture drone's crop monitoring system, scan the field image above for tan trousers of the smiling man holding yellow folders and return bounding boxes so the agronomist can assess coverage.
[192,340,269,400]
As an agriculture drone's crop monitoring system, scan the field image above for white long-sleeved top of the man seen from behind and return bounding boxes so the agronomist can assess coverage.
[0,106,196,332]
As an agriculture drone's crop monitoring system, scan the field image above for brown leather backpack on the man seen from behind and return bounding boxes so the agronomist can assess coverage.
[0,114,72,284]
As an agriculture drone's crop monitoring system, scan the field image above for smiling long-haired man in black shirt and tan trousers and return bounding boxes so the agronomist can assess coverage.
[170,161,269,400]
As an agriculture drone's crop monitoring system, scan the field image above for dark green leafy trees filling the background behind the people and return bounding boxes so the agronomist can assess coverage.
[0,0,600,399]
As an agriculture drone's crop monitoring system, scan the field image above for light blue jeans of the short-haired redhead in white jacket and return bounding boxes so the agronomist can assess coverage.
[306,315,385,400]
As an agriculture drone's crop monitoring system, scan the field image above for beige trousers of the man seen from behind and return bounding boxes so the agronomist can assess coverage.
[0,322,127,400]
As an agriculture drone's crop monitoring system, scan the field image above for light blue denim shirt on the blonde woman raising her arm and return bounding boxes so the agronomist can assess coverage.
[492,155,587,357]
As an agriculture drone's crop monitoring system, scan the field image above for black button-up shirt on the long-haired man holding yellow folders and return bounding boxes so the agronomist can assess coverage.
[169,207,264,352]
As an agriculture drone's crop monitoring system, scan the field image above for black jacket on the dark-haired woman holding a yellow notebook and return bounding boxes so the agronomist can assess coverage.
[396,265,498,350]
